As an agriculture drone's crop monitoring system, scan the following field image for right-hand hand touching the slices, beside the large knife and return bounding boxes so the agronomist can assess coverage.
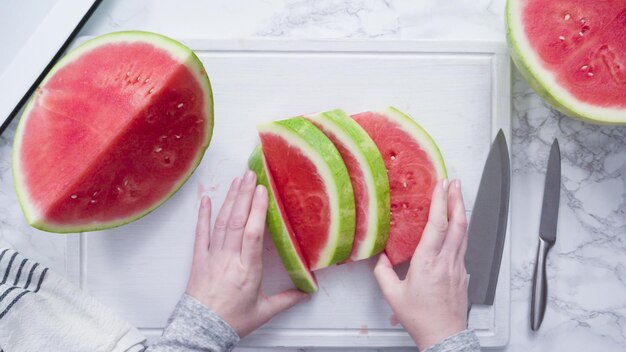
[374,180,467,351]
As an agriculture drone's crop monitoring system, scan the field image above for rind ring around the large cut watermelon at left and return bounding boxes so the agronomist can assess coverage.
[12,31,214,233]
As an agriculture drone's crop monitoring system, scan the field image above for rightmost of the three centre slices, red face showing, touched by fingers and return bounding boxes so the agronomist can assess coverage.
[352,107,447,265]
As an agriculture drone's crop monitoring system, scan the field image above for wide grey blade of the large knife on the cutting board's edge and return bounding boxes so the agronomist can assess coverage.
[465,130,511,306]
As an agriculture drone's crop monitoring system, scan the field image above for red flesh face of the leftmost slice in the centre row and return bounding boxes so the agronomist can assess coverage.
[260,133,330,270]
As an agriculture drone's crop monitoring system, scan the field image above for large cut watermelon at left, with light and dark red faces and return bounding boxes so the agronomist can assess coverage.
[13,32,213,232]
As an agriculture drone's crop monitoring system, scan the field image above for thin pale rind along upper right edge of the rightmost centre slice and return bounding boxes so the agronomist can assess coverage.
[377,106,448,179]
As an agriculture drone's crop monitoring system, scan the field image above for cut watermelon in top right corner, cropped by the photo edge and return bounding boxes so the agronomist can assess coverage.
[506,0,626,124]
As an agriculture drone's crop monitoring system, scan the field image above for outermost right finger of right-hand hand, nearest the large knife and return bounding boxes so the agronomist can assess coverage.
[442,180,467,260]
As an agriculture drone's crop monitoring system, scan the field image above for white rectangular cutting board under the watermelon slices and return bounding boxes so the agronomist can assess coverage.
[67,40,511,347]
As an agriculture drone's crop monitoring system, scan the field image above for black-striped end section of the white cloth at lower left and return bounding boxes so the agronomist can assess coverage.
[0,248,48,322]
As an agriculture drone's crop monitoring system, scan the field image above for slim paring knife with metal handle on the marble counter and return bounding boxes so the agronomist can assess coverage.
[530,139,561,331]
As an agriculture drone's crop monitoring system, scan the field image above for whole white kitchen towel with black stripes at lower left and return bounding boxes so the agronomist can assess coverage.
[0,247,146,352]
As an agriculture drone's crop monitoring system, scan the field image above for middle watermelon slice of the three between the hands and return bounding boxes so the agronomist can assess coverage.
[307,110,389,261]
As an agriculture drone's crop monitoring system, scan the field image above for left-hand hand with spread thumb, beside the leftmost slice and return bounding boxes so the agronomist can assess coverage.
[186,171,309,337]
